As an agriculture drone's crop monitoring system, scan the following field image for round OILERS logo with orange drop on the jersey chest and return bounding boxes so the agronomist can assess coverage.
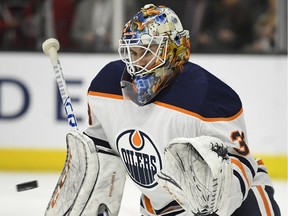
[116,130,162,188]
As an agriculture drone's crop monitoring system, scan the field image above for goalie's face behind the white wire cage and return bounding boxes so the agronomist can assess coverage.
[130,45,158,70]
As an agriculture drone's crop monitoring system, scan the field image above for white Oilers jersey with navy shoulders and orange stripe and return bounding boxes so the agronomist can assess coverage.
[85,61,271,215]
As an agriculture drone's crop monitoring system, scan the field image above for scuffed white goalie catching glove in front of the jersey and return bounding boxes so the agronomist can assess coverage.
[156,136,232,215]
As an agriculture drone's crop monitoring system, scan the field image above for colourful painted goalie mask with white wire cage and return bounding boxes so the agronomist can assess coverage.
[118,4,190,105]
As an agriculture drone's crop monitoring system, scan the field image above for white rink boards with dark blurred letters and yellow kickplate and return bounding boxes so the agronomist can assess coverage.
[0,52,287,179]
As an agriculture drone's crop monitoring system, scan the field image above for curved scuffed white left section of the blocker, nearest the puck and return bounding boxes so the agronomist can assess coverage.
[45,130,99,216]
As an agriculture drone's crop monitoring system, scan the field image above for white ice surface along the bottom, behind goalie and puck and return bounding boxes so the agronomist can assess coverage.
[0,172,288,216]
